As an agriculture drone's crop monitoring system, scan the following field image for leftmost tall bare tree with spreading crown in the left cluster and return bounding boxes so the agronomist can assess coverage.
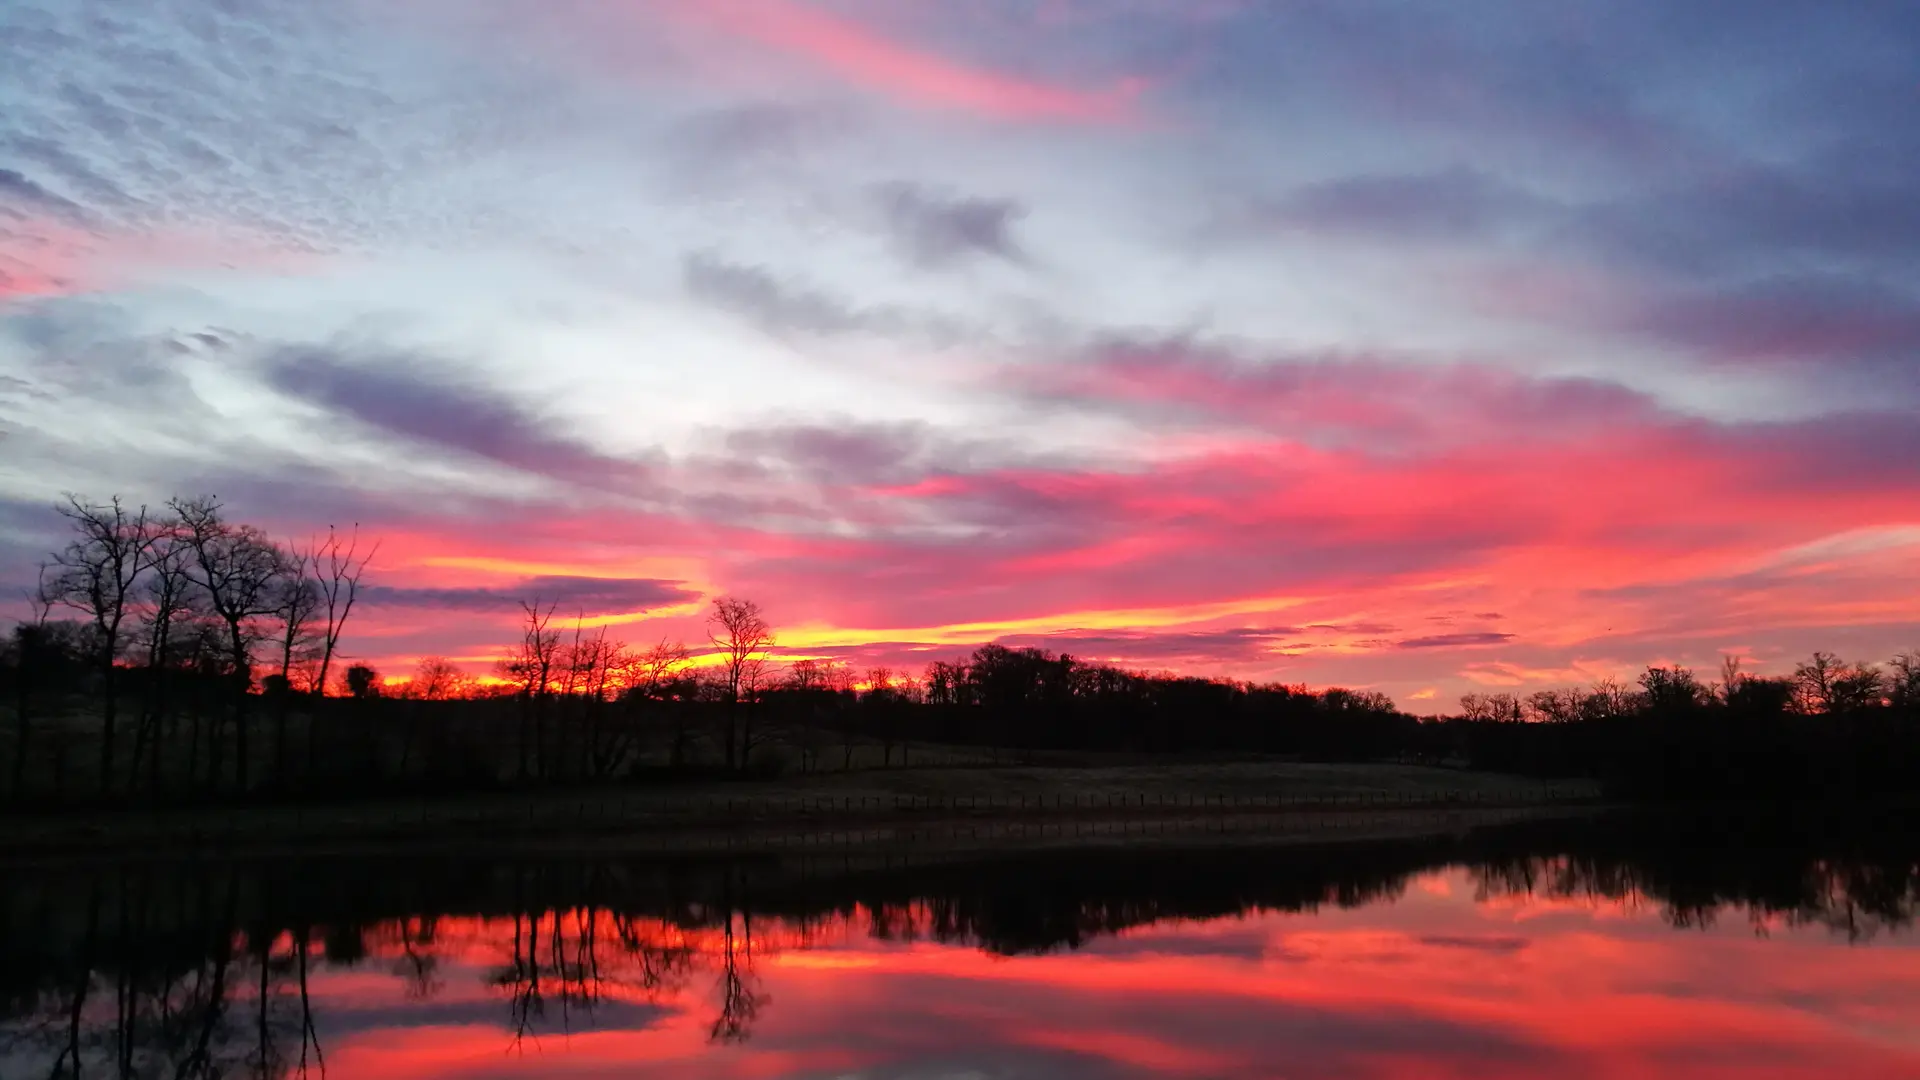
[48,494,159,794]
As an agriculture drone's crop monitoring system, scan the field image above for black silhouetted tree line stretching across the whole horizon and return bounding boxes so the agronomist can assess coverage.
[0,496,1920,801]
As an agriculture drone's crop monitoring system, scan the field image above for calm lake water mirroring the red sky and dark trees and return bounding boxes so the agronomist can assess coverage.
[0,814,1920,1080]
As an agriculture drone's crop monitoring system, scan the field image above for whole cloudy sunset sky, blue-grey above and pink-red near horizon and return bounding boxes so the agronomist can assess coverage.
[0,0,1920,711]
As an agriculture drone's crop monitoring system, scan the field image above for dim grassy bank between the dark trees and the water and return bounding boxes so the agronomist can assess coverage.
[0,761,1599,859]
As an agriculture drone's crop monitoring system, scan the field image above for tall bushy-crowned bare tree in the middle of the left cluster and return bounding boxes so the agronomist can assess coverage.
[169,496,284,790]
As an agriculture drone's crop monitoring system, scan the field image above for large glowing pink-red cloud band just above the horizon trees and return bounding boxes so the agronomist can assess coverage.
[299,349,1920,701]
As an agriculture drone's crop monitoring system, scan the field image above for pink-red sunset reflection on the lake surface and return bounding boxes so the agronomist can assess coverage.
[263,871,1920,1080]
